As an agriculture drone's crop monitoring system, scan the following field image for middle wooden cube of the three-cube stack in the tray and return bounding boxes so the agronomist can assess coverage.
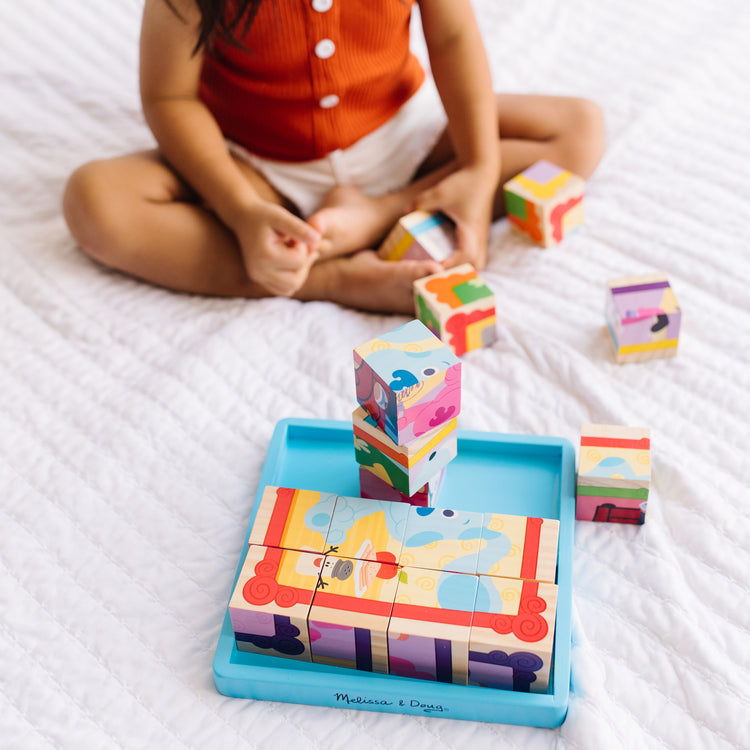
[352,406,458,497]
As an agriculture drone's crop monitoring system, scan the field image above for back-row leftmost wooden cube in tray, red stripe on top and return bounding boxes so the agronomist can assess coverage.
[249,486,336,552]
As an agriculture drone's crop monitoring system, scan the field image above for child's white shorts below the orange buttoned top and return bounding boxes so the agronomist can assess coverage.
[227,77,448,219]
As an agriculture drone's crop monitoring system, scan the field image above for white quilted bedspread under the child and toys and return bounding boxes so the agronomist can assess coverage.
[0,0,750,750]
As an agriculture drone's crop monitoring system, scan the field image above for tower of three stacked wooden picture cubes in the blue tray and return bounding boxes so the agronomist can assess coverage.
[352,320,461,506]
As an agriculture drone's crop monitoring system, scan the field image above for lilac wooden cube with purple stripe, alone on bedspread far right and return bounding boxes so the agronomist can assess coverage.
[605,273,682,363]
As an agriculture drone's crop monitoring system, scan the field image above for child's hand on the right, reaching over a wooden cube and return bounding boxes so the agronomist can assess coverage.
[415,167,497,270]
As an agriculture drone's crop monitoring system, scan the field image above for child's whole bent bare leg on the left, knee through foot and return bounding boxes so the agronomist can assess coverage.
[63,152,439,313]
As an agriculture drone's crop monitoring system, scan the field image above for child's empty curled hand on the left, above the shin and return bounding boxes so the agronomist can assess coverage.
[231,203,321,297]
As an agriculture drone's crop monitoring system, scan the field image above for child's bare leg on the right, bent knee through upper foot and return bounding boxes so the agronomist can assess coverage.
[310,94,604,257]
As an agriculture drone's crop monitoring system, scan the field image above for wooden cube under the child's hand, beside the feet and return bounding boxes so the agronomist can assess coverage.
[378,211,456,263]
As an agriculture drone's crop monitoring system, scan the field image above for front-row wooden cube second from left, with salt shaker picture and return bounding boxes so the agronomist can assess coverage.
[308,555,398,674]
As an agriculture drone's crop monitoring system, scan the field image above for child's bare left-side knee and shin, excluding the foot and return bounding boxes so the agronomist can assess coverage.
[63,152,296,297]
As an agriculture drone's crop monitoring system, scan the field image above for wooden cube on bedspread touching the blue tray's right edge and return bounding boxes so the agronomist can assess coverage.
[576,424,651,524]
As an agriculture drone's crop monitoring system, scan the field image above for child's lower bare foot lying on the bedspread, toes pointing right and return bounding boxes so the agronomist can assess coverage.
[296,250,442,315]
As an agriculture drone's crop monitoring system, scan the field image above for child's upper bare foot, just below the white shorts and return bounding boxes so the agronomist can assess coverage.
[308,185,402,258]
